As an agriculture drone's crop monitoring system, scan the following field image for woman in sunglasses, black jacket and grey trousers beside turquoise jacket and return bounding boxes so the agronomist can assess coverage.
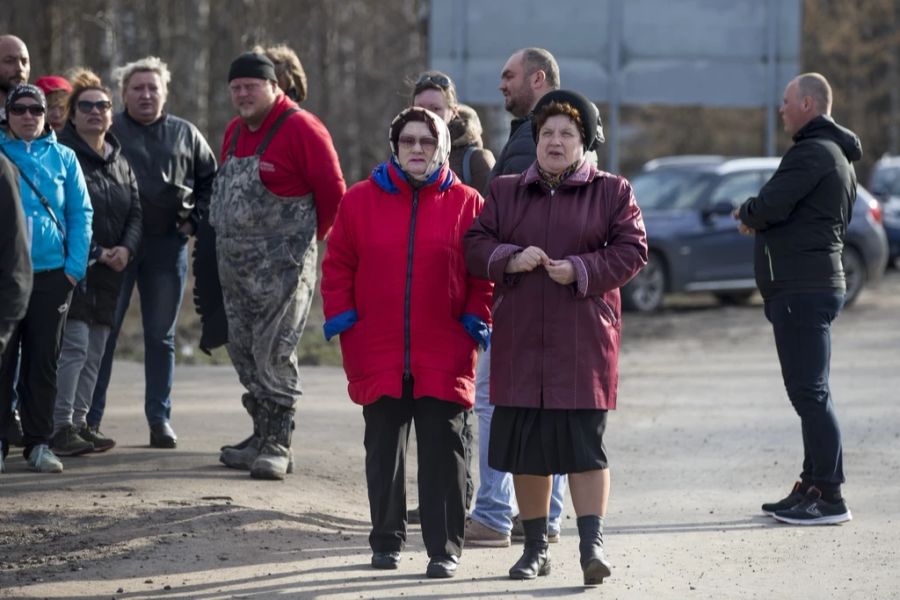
[52,70,141,456]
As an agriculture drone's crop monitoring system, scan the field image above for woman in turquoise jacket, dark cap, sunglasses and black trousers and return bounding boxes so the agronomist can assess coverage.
[0,84,93,473]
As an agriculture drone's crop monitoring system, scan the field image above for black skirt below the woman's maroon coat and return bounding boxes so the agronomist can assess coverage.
[488,406,608,475]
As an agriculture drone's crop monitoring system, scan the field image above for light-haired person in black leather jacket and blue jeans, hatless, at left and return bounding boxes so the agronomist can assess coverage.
[87,56,216,448]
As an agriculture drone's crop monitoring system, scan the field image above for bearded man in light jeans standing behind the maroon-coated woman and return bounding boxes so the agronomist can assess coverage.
[466,48,567,547]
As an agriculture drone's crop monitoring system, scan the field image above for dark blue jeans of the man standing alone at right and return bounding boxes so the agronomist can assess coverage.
[765,292,844,489]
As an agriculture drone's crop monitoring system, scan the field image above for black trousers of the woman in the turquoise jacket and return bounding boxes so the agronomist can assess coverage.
[0,269,73,456]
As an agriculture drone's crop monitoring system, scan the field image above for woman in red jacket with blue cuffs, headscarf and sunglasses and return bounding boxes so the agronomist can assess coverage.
[322,107,491,577]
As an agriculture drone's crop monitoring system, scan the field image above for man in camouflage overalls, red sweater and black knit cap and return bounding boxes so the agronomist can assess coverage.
[210,52,346,479]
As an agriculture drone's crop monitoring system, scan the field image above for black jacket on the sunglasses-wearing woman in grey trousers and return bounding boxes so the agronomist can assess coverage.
[59,122,141,325]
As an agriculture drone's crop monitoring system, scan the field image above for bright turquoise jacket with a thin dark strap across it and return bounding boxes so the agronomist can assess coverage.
[0,131,94,281]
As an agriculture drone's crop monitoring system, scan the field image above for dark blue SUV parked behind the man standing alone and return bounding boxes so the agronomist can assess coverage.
[622,156,888,312]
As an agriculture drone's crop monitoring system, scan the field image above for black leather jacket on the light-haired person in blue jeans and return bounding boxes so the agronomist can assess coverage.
[112,111,216,235]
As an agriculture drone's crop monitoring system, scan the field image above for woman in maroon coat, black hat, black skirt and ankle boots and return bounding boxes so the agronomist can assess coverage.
[465,90,647,585]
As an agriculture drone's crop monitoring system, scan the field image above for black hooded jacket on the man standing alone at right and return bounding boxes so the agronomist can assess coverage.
[740,115,862,298]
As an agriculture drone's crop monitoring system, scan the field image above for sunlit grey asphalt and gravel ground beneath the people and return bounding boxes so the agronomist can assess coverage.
[0,271,900,600]
